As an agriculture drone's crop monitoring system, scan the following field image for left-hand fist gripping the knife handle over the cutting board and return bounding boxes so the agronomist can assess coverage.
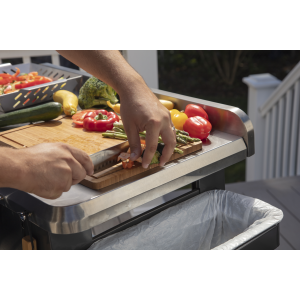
[14,143,94,199]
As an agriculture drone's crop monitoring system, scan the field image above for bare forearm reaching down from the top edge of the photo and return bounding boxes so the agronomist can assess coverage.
[57,50,145,95]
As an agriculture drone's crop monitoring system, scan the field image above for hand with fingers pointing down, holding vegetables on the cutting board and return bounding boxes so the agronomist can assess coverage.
[119,81,176,168]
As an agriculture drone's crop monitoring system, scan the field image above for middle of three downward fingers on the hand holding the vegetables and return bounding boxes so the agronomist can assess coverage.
[143,122,159,169]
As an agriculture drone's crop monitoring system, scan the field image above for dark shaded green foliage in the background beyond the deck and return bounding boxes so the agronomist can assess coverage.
[158,50,300,183]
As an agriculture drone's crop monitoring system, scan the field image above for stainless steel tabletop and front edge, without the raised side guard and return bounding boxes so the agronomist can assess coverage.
[1,130,247,234]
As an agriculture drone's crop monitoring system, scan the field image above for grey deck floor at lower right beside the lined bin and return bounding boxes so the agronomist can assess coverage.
[226,176,300,250]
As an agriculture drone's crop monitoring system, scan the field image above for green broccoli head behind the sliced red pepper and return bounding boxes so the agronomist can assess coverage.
[78,77,118,109]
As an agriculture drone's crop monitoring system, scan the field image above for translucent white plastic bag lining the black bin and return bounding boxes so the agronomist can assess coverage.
[89,190,283,250]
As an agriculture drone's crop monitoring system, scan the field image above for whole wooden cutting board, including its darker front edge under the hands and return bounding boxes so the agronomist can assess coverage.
[0,116,202,190]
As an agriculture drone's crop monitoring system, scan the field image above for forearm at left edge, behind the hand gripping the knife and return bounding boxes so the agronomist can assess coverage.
[0,147,24,189]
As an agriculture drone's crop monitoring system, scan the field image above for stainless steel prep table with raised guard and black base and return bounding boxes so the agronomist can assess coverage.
[0,65,254,249]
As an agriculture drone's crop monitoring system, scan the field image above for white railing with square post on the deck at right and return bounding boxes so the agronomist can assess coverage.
[243,63,300,180]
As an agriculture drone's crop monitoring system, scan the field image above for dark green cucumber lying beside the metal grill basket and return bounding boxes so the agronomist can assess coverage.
[0,102,63,127]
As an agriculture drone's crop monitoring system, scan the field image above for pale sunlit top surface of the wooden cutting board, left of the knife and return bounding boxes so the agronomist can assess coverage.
[0,116,123,155]
